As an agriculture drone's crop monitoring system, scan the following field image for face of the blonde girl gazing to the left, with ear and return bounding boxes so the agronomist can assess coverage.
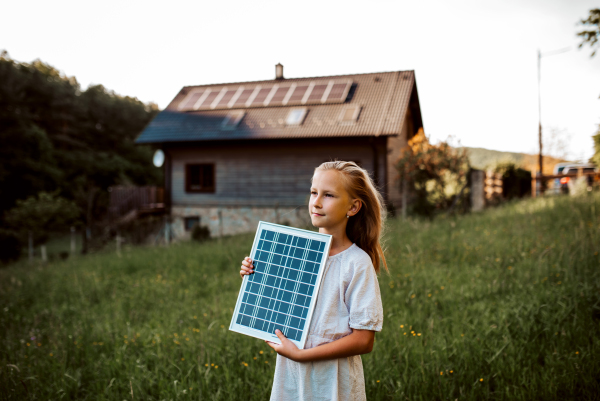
[308,170,360,229]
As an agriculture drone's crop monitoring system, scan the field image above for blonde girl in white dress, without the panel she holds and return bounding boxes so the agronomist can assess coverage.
[240,161,387,401]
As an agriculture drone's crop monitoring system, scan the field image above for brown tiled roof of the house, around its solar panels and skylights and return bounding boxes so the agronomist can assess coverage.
[136,71,418,143]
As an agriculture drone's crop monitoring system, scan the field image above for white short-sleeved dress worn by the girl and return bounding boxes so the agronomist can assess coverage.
[271,244,383,401]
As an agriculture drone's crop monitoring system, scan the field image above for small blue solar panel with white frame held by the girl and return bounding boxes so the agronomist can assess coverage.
[229,221,331,349]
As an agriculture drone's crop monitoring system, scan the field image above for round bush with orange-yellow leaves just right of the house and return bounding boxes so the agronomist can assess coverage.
[397,130,469,217]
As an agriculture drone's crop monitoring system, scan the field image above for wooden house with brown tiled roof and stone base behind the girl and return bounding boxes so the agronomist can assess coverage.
[136,64,423,236]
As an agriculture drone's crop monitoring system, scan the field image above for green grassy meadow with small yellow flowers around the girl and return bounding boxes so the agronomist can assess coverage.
[0,194,600,400]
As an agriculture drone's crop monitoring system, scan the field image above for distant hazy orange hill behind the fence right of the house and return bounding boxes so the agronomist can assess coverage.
[457,147,565,174]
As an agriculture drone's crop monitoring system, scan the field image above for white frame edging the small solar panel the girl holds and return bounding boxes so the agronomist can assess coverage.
[229,221,332,349]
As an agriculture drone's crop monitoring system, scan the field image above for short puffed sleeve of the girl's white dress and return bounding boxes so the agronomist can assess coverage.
[344,250,383,331]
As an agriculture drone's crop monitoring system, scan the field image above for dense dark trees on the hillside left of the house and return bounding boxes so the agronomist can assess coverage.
[0,52,161,260]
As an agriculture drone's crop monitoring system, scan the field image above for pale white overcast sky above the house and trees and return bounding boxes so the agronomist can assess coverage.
[0,0,600,158]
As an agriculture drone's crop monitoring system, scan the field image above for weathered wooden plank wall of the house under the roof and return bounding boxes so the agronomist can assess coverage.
[166,137,389,207]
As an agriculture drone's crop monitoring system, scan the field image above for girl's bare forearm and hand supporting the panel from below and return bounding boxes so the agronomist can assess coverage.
[267,329,375,362]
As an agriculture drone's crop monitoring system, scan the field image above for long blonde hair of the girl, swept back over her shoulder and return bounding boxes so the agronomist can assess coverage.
[315,160,388,273]
